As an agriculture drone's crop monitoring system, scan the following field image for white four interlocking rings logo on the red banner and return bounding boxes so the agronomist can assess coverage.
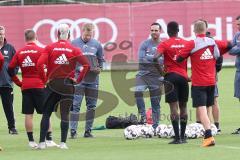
[33,18,118,47]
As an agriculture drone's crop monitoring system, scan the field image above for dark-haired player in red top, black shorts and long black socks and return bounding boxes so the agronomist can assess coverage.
[155,21,189,144]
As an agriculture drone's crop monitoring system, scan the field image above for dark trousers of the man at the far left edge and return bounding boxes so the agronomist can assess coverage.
[0,87,15,129]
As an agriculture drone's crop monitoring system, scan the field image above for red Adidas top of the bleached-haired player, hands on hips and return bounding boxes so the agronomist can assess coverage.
[37,40,90,83]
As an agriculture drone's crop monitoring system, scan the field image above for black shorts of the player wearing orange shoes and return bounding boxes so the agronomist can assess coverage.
[191,85,215,107]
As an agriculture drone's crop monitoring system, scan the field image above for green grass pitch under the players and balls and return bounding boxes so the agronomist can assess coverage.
[0,68,240,160]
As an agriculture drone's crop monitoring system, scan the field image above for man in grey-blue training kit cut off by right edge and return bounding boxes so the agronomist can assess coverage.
[229,16,240,134]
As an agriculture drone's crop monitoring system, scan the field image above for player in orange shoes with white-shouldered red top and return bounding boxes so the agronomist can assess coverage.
[177,20,220,147]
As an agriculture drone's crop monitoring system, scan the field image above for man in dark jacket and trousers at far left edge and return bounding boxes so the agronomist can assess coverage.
[0,26,18,135]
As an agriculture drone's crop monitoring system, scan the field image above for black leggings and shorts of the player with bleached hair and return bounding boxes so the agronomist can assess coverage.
[39,79,74,142]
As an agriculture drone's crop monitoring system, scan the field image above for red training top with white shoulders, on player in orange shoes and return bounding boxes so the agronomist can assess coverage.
[177,34,224,86]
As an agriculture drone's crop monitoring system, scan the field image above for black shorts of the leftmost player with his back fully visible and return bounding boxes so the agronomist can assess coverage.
[22,88,45,114]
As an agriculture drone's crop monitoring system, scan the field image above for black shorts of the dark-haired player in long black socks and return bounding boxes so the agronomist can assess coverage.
[164,73,189,103]
